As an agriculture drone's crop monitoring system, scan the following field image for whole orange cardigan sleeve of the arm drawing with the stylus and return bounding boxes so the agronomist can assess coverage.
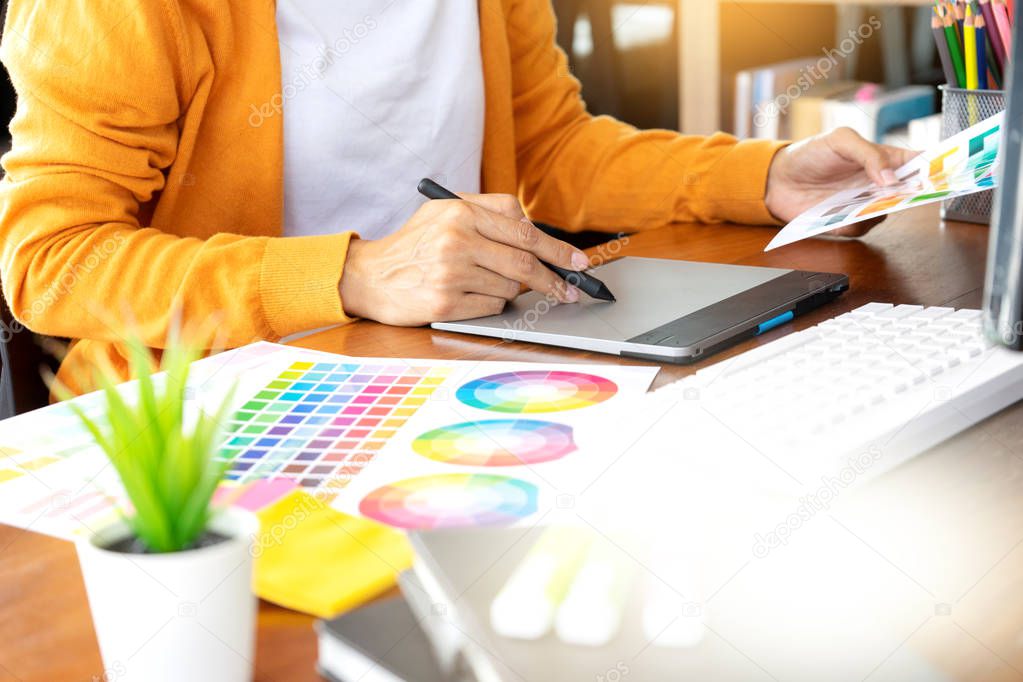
[0,0,351,348]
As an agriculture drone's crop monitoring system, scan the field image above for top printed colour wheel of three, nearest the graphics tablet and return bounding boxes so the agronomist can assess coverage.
[456,370,618,414]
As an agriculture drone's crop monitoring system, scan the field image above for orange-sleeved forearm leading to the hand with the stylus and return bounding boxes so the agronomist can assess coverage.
[0,175,350,348]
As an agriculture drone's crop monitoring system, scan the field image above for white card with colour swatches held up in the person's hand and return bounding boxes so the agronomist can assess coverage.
[764,113,1004,251]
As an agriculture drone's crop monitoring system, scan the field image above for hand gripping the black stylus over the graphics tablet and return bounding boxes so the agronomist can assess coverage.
[341,194,589,326]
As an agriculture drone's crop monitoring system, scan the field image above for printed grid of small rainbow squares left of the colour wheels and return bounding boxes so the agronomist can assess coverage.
[221,362,450,489]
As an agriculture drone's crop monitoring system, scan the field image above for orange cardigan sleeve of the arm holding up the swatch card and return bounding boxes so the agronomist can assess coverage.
[505,0,784,230]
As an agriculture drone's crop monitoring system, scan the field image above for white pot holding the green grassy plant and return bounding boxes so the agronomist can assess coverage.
[77,509,258,682]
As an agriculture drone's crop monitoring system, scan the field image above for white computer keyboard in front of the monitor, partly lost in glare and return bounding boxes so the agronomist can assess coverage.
[658,303,1023,485]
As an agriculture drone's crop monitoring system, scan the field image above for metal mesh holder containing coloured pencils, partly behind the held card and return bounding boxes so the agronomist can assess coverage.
[939,85,1006,223]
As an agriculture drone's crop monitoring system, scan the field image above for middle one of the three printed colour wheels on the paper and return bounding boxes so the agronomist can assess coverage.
[412,419,576,466]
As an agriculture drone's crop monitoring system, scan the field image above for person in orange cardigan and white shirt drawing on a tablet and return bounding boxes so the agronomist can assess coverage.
[0,0,909,389]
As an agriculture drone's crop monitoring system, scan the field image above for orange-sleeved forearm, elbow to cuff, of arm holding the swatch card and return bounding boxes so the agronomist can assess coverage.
[520,117,782,231]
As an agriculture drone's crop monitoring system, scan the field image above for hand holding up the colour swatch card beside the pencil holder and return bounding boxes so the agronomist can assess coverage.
[764,128,919,236]
